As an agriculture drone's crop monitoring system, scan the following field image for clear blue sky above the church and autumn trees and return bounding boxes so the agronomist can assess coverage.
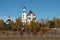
[0,0,60,20]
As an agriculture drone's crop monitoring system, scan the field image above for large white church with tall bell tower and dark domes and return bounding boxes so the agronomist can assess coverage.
[22,7,36,23]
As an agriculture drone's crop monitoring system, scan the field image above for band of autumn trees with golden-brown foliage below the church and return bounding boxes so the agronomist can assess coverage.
[0,17,60,34]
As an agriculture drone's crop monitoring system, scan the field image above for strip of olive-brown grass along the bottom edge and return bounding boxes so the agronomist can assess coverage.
[0,38,60,40]
